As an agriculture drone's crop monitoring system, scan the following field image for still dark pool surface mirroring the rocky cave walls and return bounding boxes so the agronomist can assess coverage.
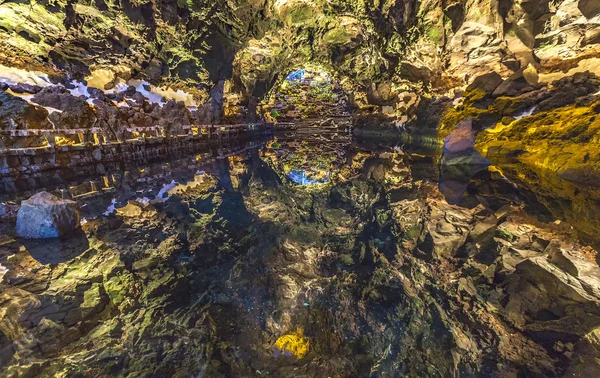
[0,135,600,378]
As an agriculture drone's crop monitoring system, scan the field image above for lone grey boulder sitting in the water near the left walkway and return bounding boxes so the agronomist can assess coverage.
[17,192,79,239]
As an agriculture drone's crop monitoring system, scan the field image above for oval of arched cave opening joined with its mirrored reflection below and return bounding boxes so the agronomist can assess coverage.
[263,66,351,187]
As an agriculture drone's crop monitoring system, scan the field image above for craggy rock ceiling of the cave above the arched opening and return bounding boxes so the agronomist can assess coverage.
[0,0,600,106]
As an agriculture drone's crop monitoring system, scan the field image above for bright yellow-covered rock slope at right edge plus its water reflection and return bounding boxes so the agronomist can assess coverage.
[475,101,600,242]
